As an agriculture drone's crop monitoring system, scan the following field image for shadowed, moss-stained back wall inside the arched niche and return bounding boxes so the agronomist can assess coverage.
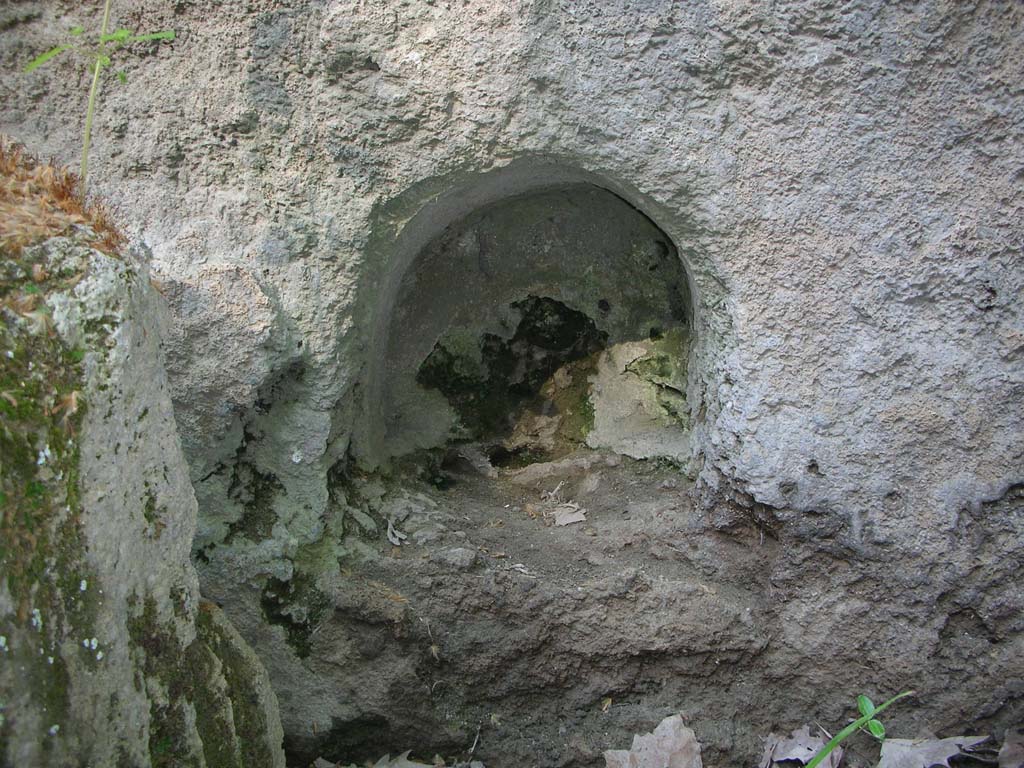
[382,184,690,461]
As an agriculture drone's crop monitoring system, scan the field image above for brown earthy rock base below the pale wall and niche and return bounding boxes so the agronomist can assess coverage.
[278,450,1024,768]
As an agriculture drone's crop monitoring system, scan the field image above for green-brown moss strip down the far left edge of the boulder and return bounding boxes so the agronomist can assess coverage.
[0,247,97,749]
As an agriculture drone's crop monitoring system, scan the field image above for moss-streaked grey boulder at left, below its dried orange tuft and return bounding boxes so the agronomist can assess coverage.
[0,225,284,768]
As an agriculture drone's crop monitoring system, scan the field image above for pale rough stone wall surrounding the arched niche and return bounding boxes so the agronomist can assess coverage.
[2,2,1021,565]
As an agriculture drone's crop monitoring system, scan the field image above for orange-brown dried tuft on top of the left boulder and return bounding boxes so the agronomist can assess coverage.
[0,135,126,256]
